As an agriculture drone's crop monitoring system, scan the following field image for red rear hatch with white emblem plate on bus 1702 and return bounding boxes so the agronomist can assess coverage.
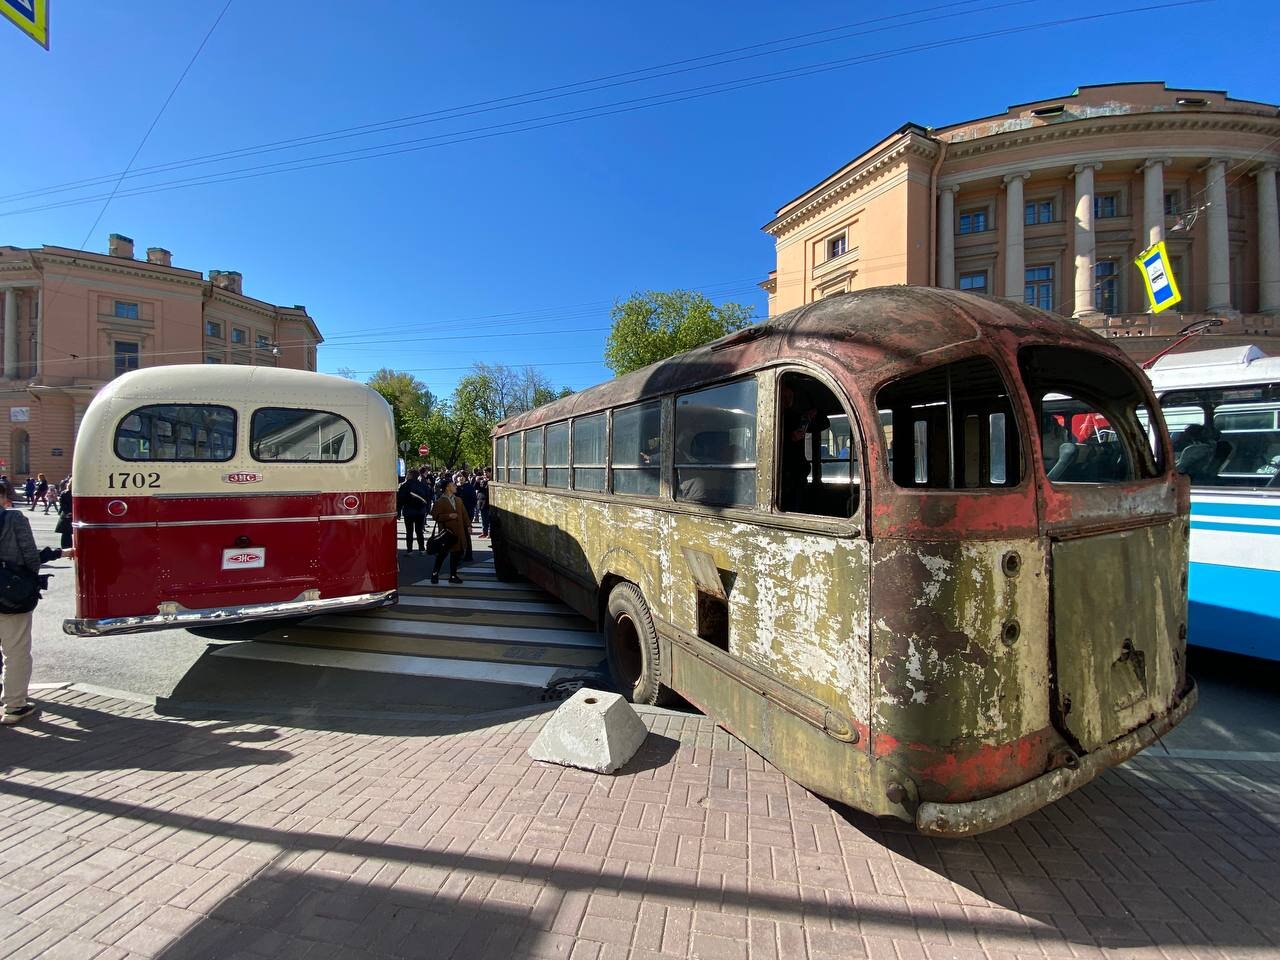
[155,491,321,609]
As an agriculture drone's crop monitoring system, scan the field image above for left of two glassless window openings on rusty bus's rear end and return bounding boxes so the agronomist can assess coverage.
[876,357,1023,489]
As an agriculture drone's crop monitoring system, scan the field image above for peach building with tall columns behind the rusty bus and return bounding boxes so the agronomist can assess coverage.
[762,83,1280,357]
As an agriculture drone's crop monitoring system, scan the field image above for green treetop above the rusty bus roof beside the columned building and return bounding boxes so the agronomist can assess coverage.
[604,291,754,376]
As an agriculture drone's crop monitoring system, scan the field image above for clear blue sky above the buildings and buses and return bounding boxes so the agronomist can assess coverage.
[0,0,1280,394]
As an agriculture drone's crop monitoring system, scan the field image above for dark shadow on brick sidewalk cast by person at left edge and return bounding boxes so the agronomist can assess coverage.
[0,703,285,773]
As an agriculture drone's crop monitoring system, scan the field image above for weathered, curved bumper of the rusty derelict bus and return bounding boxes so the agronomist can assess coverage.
[915,681,1199,837]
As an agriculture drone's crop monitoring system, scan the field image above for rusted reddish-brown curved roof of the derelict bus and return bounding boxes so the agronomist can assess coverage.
[494,285,1128,434]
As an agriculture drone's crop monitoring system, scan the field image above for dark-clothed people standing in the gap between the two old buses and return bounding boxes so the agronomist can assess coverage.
[396,467,493,584]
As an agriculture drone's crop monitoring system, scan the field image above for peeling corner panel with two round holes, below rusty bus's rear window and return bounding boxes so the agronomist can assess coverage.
[872,539,1064,800]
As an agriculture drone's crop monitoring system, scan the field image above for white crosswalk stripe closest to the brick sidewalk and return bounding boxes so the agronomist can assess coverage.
[214,641,565,689]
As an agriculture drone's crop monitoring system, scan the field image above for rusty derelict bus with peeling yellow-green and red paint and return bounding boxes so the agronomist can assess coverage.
[492,287,1196,836]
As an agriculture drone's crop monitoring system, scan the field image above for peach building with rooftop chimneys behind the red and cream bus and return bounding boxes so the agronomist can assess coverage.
[0,233,324,480]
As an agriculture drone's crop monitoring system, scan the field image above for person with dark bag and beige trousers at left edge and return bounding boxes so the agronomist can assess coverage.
[0,480,76,727]
